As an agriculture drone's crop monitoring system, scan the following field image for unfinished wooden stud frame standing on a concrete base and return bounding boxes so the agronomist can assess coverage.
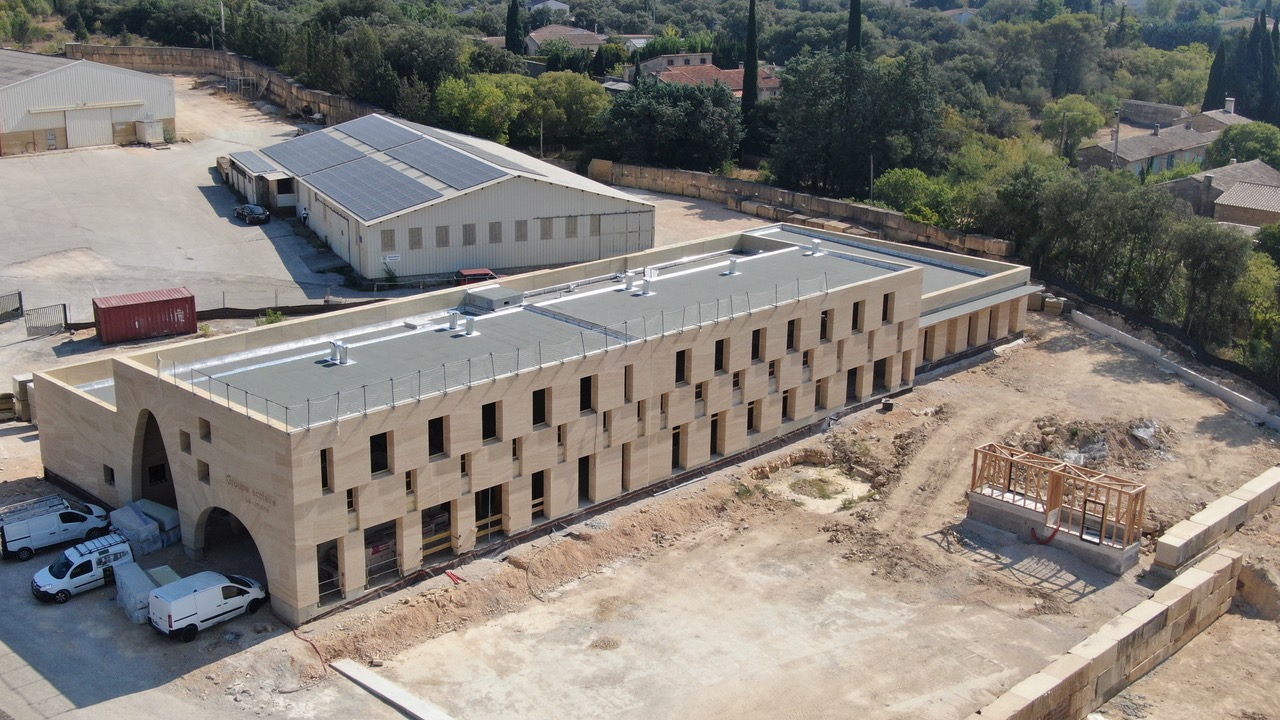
[969,442,1147,548]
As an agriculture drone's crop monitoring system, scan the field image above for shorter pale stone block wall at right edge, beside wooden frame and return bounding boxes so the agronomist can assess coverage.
[1156,468,1280,575]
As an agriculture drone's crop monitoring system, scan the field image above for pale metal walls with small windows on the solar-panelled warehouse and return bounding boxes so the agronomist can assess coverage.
[300,177,654,278]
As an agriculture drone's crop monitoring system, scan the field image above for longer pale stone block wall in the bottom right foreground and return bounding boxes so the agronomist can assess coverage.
[968,550,1243,720]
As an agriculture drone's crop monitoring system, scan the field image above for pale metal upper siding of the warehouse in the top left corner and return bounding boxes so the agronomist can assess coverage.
[0,63,175,133]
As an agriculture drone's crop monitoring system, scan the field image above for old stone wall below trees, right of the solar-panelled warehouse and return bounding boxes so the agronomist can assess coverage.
[588,160,1016,260]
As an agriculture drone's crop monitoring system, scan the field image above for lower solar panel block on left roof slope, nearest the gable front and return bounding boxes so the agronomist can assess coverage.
[307,158,442,223]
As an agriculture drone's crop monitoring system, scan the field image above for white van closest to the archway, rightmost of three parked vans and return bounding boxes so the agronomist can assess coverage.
[147,570,268,643]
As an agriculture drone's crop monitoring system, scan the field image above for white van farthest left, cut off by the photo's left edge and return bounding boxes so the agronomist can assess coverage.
[0,495,110,560]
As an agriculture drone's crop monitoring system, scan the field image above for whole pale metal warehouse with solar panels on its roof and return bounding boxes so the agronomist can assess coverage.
[229,115,654,278]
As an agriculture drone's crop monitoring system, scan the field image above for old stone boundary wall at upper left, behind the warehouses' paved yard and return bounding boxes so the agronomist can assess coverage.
[65,42,383,124]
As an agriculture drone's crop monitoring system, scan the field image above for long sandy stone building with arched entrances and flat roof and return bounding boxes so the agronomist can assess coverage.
[32,224,1039,623]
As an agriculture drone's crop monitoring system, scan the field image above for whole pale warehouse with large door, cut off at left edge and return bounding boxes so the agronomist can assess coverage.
[0,50,174,155]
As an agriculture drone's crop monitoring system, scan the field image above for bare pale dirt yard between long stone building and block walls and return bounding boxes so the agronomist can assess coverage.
[272,315,1280,720]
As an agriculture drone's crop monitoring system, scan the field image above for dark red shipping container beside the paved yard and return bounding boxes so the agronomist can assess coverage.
[93,287,196,345]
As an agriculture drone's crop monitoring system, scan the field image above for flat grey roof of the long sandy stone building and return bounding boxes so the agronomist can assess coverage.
[72,225,1029,428]
